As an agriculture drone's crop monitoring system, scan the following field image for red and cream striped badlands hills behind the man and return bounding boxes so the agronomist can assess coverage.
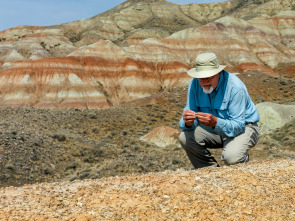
[0,0,295,108]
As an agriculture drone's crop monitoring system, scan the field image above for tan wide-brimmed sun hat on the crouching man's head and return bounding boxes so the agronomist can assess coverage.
[187,53,226,78]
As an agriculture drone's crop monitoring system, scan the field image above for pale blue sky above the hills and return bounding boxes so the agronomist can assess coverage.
[0,0,226,31]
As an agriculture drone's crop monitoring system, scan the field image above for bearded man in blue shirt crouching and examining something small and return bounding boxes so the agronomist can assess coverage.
[179,53,259,168]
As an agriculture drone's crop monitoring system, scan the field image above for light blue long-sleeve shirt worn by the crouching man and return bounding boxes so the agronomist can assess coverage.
[179,71,259,137]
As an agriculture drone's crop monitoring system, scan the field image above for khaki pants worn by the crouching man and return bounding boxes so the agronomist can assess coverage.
[179,123,259,168]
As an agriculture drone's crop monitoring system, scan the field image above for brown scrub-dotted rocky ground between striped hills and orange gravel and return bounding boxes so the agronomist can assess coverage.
[0,72,295,187]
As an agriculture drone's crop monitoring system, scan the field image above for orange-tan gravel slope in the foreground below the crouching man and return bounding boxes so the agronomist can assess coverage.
[0,160,295,221]
